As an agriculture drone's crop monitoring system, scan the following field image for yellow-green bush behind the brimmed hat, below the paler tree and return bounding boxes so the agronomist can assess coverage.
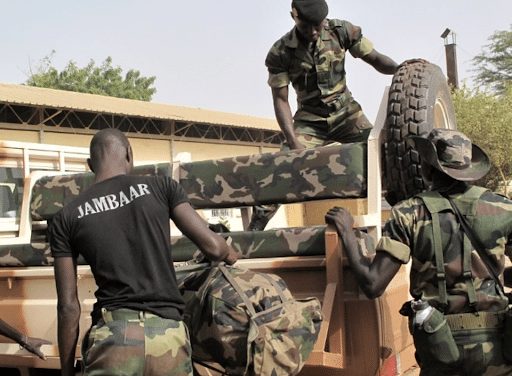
[453,83,512,194]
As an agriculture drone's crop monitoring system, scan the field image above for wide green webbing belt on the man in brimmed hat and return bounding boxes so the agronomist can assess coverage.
[445,311,505,332]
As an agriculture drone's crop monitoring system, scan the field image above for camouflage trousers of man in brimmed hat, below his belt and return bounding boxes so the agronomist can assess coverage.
[418,329,512,376]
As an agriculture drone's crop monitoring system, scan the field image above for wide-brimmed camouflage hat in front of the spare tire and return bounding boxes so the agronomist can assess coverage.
[407,129,491,181]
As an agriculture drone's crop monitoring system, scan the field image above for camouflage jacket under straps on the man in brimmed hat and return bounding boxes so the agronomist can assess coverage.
[377,186,512,314]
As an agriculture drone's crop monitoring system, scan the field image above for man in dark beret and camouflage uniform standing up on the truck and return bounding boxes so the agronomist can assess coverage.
[249,0,398,230]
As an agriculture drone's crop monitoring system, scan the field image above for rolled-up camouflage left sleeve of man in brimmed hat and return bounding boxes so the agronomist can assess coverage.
[376,206,412,264]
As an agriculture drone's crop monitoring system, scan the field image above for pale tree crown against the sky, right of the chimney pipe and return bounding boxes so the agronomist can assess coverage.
[471,24,512,95]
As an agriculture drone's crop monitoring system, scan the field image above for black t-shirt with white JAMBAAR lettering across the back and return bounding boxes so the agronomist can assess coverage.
[50,175,189,320]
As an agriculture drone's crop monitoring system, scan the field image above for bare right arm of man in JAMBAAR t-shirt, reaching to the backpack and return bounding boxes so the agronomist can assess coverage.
[171,203,237,265]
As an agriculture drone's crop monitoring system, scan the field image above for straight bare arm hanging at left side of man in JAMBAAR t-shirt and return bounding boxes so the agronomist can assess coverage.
[54,257,80,376]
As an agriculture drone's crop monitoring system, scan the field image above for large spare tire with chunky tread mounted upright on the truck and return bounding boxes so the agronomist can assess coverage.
[384,60,457,205]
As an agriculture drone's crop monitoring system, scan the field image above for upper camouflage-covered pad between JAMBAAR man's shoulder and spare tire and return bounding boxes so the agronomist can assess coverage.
[179,142,367,209]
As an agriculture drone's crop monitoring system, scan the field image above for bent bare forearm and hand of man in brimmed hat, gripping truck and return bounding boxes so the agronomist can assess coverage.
[325,207,402,299]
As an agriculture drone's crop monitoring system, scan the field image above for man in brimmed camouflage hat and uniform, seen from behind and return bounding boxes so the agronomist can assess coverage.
[326,129,512,376]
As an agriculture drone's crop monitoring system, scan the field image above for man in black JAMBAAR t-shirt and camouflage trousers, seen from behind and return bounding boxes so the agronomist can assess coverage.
[50,129,236,375]
